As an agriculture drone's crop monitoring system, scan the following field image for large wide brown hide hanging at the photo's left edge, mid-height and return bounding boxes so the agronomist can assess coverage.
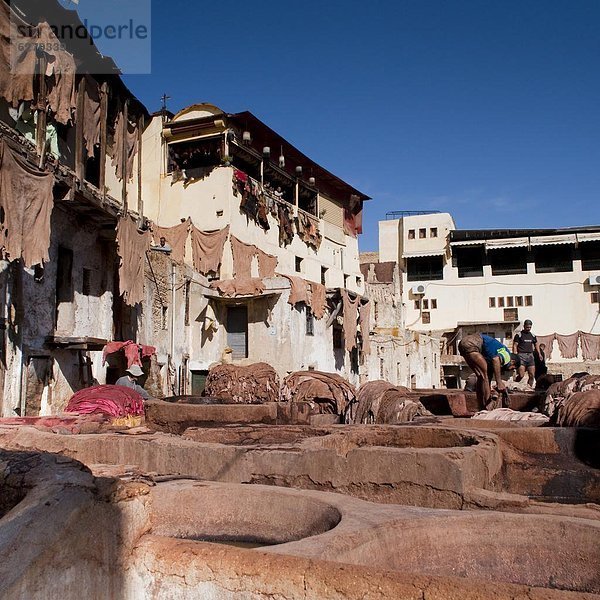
[0,141,54,267]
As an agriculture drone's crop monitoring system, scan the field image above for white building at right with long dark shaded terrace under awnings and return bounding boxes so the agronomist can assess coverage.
[379,213,600,386]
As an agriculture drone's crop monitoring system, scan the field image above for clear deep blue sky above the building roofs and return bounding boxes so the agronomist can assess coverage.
[115,0,600,251]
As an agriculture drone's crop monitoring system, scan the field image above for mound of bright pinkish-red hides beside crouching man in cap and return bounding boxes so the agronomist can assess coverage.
[66,385,144,417]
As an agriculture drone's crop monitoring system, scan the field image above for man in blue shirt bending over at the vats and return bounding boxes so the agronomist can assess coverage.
[458,333,520,410]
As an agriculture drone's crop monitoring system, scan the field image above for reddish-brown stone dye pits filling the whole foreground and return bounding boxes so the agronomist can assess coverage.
[0,413,600,600]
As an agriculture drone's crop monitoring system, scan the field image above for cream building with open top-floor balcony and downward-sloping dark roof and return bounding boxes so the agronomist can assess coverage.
[140,104,368,393]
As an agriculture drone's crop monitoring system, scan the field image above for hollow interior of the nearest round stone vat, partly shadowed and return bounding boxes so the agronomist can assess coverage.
[151,481,341,547]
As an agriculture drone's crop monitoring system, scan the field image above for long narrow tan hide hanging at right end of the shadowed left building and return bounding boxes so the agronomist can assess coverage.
[117,216,150,306]
